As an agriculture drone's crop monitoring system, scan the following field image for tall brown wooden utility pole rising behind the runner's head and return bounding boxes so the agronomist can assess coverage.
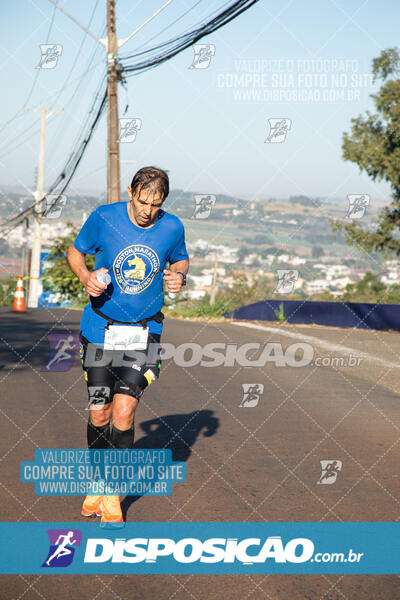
[107,0,121,204]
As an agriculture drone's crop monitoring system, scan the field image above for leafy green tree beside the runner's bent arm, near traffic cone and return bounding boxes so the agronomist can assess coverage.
[43,223,94,306]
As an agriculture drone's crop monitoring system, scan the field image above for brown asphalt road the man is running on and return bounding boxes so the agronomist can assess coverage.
[0,308,400,600]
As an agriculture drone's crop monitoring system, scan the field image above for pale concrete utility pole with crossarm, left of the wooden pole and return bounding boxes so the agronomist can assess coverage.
[24,106,64,308]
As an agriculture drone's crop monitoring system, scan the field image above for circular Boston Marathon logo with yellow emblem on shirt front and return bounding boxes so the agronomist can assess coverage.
[113,244,160,294]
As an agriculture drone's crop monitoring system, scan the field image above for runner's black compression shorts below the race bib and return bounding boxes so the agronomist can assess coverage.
[79,332,161,405]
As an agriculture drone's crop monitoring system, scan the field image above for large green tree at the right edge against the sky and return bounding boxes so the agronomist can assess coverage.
[331,47,400,255]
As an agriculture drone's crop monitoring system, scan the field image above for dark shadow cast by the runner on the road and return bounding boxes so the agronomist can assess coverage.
[121,410,219,520]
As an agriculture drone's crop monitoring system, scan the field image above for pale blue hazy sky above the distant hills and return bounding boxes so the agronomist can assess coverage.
[0,0,400,202]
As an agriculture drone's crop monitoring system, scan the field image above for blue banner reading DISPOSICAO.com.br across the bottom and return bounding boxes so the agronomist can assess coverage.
[0,522,400,575]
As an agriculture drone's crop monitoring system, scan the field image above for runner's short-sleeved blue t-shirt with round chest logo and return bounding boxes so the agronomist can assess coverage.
[74,202,189,344]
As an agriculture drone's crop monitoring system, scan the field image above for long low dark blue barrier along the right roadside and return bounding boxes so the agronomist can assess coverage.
[223,300,400,330]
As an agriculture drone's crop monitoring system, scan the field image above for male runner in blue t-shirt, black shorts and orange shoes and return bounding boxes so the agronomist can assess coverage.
[67,167,189,522]
